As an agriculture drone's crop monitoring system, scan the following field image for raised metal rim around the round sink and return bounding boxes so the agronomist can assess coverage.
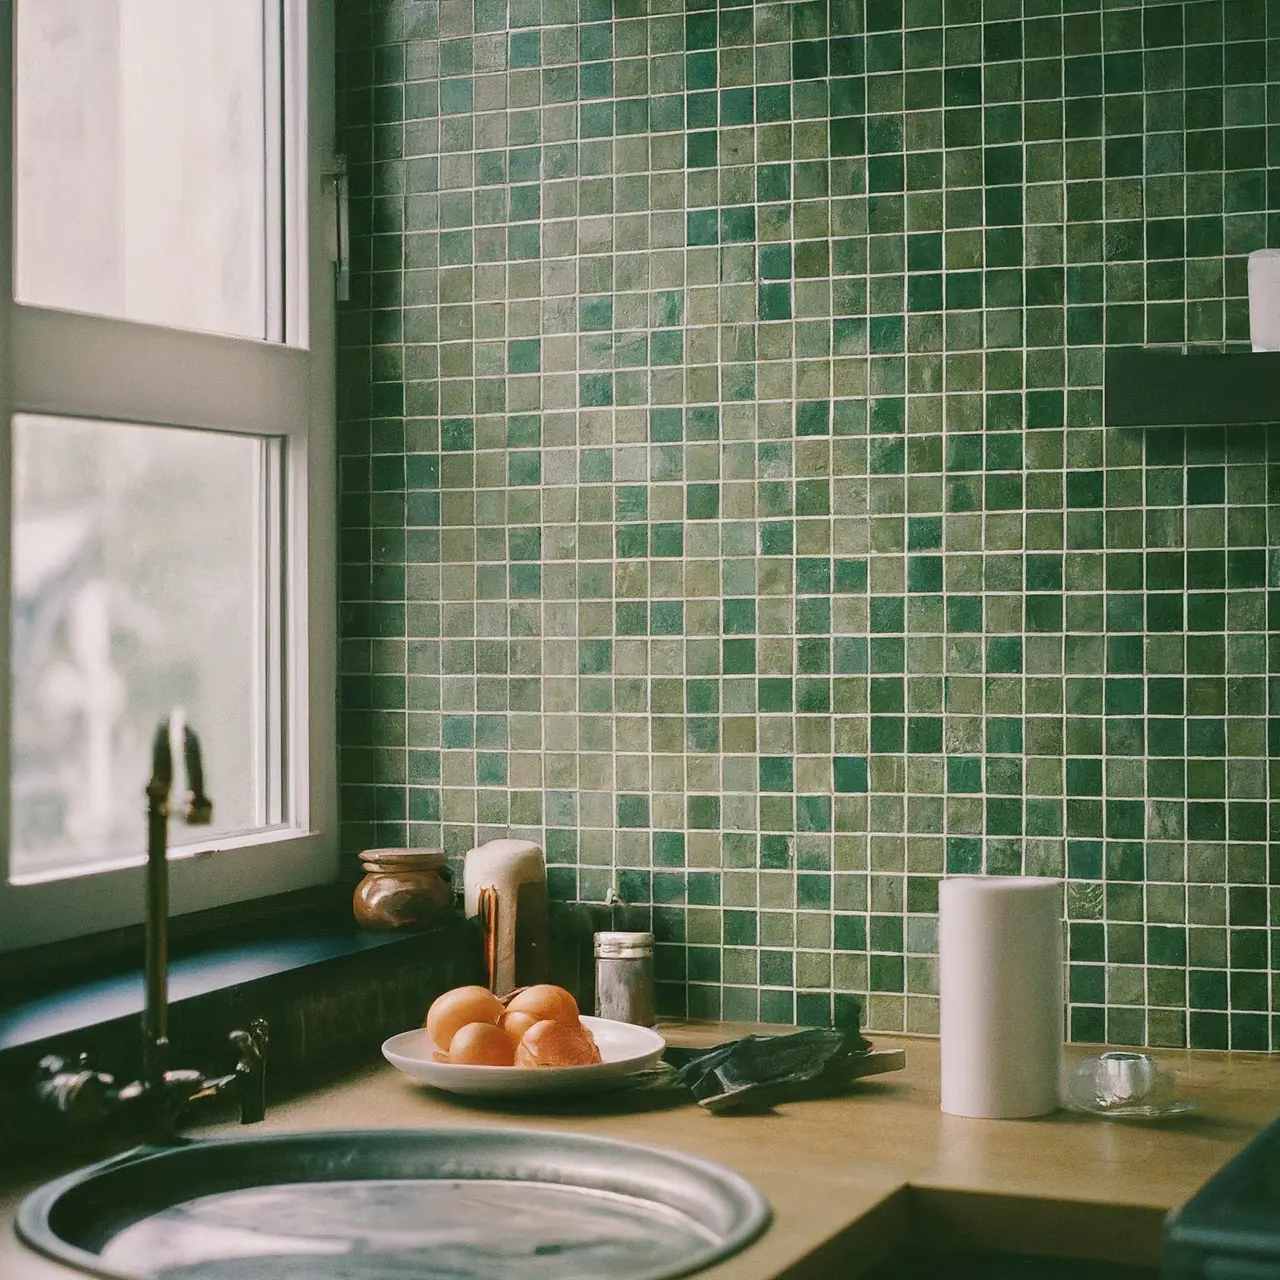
[14,1125,773,1280]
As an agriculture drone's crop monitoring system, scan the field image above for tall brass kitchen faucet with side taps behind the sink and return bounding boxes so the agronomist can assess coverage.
[36,716,268,1142]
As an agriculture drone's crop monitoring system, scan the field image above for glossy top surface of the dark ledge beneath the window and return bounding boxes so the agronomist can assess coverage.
[0,925,450,1055]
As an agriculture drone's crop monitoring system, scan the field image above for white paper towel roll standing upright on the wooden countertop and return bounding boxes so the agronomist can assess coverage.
[938,876,1062,1119]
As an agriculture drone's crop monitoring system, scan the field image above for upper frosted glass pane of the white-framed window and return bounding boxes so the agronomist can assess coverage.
[14,0,272,338]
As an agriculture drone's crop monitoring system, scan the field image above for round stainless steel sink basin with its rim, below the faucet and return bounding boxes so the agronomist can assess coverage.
[17,1128,769,1280]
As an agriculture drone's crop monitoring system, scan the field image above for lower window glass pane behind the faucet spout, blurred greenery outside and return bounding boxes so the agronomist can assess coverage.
[10,415,275,876]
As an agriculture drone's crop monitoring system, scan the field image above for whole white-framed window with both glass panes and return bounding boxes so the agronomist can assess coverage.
[0,0,337,950]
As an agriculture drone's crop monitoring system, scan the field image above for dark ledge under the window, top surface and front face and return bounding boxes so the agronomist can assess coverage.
[0,914,483,1155]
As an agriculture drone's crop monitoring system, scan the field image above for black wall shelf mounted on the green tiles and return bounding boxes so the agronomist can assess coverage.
[1102,347,1280,426]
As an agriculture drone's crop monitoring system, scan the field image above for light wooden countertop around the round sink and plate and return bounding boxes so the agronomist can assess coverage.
[0,1024,1280,1280]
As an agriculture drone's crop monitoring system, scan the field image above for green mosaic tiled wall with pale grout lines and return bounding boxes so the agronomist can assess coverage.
[339,0,1280,1048]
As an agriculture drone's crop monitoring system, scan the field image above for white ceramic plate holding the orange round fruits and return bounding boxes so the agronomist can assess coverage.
[383,1015,667,1098]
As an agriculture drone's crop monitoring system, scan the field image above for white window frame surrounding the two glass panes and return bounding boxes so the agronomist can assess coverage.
[0,0,338,952]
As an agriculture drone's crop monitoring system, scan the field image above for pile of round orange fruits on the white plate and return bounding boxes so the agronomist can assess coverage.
[424,983,600,1066]
